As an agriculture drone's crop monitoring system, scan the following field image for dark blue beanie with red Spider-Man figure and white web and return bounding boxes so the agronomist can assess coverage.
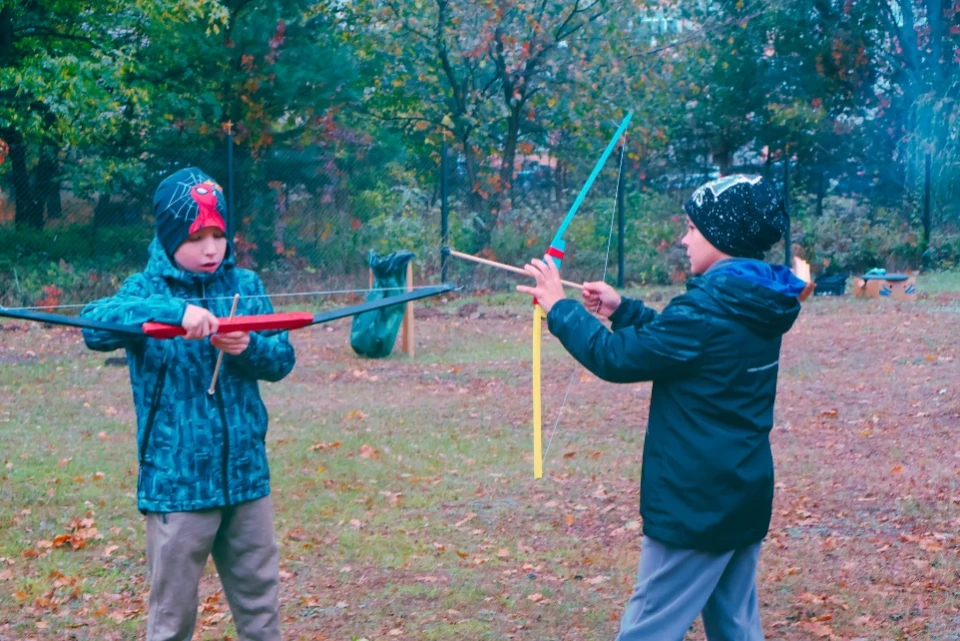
[153,167,227,258]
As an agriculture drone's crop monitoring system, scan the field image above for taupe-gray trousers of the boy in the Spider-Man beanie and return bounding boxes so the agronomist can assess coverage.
[147,496,280,641]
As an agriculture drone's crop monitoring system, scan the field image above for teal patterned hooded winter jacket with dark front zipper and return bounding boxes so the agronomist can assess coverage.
[82,240,295,513]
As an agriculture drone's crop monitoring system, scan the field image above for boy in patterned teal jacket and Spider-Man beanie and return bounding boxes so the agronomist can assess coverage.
[83,168,295,641]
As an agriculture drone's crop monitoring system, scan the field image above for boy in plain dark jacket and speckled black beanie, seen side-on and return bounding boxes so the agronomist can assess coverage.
[517,175,804,641]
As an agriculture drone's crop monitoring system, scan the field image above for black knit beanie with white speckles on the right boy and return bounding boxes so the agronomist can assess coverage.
[683,174,789,272]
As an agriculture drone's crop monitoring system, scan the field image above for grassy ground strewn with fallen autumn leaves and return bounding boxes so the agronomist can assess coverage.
[0,274,960,641]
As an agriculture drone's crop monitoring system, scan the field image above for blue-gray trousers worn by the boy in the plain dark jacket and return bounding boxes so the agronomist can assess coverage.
[616,537,763,641]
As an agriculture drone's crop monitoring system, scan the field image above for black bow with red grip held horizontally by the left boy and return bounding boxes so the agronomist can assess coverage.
[0,283,455,338]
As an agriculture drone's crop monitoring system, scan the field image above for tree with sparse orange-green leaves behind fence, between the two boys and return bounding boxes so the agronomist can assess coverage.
[353,0,632,249]
